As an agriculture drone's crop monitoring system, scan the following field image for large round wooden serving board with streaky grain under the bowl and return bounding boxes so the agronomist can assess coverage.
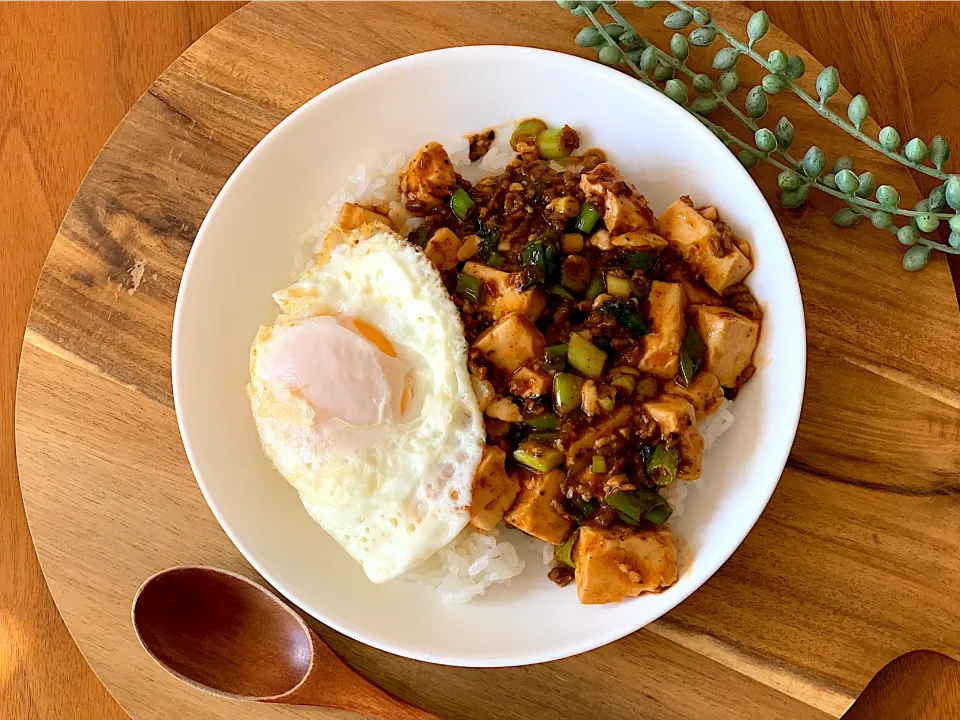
[17,0,960,720]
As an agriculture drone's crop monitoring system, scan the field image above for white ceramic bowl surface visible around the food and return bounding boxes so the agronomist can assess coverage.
[173,47,806,667]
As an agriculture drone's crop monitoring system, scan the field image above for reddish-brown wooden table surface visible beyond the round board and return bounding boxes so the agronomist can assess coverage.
[0,0,960,718]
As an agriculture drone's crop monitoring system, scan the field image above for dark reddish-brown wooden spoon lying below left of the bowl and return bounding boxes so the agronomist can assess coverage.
[133,565,437,720]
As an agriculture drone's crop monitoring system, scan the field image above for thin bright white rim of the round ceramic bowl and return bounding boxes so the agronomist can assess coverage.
[171,45,807,668]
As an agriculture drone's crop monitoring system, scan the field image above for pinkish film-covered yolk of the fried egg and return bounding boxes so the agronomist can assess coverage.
[264,315,412,425]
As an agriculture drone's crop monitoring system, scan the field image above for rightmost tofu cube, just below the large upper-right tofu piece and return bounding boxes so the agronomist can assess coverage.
[691,305,760,387]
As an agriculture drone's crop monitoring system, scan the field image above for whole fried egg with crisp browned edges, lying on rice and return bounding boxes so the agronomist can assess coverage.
[247,224,484,583]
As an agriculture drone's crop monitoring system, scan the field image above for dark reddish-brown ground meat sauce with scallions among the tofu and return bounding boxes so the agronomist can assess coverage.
[394,121,762,585]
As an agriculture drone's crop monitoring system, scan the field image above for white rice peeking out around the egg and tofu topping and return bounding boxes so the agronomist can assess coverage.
[291,134,733,604]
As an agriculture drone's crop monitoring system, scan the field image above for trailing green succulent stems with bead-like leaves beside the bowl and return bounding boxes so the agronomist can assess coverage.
[557,0,960,271]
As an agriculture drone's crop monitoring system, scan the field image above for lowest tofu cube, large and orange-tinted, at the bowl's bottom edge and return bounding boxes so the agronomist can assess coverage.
[574,525,678,605]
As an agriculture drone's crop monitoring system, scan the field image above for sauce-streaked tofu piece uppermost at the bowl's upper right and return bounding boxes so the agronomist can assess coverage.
[657,200,753,294]
